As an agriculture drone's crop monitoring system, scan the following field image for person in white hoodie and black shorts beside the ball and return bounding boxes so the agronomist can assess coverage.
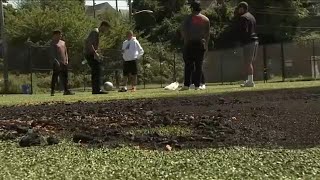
[119,31,144,92]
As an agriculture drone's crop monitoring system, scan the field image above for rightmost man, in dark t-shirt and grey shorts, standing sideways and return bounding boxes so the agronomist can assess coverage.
[236,2,259,87]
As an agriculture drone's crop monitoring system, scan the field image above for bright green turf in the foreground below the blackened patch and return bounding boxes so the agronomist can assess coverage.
[0,142,320,180]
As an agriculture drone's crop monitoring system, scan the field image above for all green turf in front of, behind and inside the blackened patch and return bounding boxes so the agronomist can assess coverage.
[0,81,320,180]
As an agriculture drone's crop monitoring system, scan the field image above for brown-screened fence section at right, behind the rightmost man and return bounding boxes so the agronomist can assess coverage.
[204,40,320,83]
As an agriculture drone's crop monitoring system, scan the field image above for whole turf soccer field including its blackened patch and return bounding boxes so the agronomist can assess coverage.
[0,81,320,179]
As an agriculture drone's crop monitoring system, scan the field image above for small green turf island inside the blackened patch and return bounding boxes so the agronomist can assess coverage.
[128,126,193,136]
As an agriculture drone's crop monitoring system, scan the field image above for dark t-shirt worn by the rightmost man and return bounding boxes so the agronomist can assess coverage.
[238,12,258,44]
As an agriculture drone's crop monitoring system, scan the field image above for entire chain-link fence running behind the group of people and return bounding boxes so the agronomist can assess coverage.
[0,40,320,93]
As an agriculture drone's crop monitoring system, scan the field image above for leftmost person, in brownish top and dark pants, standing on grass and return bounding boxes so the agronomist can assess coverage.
[50,30,74,96]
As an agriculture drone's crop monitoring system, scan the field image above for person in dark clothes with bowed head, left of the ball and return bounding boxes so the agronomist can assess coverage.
[84,21,110,94]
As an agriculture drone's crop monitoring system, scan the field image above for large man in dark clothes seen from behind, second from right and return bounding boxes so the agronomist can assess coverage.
[181,1,210,91]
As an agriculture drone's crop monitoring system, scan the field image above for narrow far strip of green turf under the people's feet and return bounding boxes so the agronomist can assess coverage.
[0,81,320,105]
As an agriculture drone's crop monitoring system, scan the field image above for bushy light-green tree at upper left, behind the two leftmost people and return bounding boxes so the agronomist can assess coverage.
[6,0,95,69]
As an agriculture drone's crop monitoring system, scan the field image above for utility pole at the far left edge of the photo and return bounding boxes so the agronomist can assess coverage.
[0,0,9,93]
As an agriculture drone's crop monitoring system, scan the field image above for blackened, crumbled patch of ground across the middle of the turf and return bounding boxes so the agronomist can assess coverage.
[0,88,320,149]
